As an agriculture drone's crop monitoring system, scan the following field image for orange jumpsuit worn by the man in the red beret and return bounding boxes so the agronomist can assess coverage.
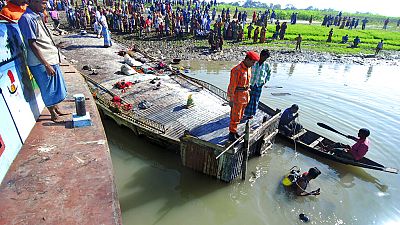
[228,62,251,133]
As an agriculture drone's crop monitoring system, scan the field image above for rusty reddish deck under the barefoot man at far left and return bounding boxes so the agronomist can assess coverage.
[0,62,121,224]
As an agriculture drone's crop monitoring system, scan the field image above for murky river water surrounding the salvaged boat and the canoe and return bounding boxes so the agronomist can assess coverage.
[104,62,400,225]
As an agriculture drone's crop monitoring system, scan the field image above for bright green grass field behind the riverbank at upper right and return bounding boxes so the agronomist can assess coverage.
[211,4,400,54]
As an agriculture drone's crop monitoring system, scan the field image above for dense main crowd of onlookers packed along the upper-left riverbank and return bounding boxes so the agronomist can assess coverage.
[60,0,297,50]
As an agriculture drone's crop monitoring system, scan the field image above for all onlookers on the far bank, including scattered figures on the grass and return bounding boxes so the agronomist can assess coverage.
[0,0,400,53]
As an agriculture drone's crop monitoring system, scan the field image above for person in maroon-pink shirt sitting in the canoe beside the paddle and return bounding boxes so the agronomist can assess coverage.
[328,128,370,161]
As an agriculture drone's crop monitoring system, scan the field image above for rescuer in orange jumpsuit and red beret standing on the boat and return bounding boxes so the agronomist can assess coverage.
[228,51,260,141]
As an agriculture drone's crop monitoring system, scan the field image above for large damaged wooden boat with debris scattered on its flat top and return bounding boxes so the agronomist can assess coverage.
[59,40,280,182]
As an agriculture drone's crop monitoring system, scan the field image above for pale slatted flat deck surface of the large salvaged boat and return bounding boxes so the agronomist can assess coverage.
[63,36,266,145]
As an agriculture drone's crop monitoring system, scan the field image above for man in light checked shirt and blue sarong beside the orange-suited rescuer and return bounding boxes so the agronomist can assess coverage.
[244,49,271,119]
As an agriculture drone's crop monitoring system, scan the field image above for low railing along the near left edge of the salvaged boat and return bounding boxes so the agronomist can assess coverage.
[82,74,167,133]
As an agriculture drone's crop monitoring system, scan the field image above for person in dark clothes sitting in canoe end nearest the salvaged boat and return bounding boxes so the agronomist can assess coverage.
[278,104,303,136]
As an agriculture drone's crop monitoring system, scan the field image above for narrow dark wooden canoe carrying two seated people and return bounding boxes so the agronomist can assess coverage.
[279,129,398,174]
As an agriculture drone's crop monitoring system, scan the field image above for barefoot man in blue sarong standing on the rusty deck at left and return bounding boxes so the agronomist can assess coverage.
[18,0,67,122]
